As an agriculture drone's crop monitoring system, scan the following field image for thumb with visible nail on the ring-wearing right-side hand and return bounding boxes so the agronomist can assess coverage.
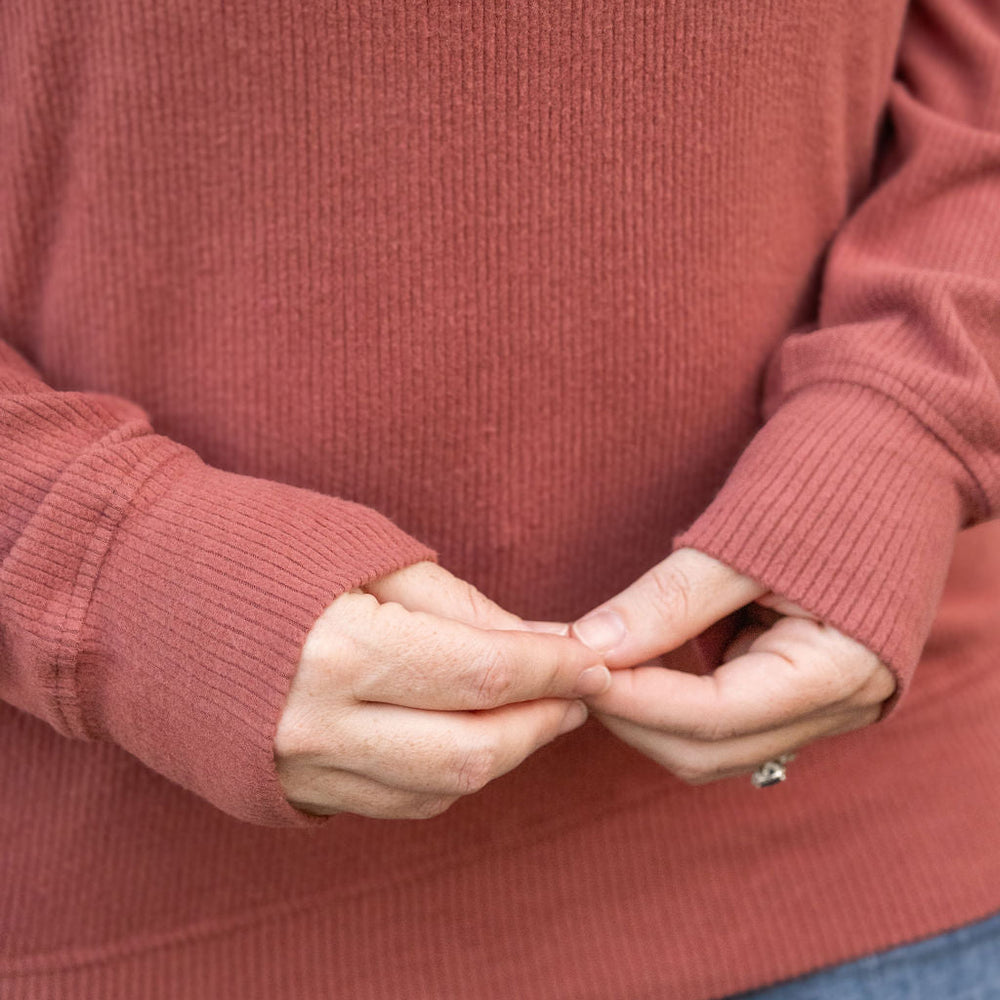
[571,548,768,667]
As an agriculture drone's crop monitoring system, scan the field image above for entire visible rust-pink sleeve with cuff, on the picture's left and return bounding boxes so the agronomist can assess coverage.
[0,341,433,825]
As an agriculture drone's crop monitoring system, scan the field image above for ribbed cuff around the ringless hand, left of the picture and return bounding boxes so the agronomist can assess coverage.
[76,452,434,825]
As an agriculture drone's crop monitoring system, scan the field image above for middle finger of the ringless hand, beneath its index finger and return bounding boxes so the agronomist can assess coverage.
[316,700,587,795]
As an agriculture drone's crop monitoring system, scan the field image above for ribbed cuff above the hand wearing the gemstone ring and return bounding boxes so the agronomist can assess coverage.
[673,383,962,708]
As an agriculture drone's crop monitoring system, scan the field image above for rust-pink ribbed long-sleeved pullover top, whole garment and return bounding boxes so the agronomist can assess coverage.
[0,0,1000,1000]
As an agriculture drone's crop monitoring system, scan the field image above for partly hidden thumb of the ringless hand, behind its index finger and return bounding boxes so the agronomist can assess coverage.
[364,561,523,629]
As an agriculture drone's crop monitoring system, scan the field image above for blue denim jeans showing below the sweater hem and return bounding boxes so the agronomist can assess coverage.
[732,914,1000,1000]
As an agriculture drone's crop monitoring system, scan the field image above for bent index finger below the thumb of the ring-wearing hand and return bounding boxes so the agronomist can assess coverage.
[590,618,895,740]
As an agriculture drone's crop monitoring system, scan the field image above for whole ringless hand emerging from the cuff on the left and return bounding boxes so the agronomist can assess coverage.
[274,562,611,819]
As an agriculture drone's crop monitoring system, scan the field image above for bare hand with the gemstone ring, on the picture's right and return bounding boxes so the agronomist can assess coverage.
[572,548,896,784]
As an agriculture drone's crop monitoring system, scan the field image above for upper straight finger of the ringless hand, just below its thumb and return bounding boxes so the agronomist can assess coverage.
[344,604,610,711]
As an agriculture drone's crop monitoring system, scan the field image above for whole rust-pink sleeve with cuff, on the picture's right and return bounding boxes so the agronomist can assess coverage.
[674,0,1000,701]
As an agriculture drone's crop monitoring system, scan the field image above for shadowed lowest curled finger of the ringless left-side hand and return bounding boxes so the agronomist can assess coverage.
[280,768,457,819]
